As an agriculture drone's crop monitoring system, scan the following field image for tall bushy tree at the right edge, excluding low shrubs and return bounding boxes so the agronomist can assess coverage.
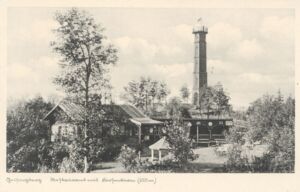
[248,92,295,172]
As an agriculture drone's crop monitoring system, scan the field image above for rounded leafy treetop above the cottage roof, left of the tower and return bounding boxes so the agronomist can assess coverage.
[122,77,170,114]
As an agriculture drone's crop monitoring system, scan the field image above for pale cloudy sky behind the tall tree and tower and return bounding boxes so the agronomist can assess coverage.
[7,7,295,109]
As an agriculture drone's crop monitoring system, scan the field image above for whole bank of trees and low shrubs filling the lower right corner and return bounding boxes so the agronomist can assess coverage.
[226,92,295,172]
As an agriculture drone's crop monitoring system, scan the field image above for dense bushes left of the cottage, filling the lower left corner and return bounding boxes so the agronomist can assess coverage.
[7,97,107,172]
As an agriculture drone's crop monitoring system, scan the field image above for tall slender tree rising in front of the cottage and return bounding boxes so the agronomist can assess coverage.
[51,8,117,172]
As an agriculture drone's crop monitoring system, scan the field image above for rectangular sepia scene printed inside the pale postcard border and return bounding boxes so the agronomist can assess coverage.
[4,6,295,174]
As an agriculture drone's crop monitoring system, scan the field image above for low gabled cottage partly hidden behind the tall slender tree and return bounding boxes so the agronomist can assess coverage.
[44,100,163,143]
